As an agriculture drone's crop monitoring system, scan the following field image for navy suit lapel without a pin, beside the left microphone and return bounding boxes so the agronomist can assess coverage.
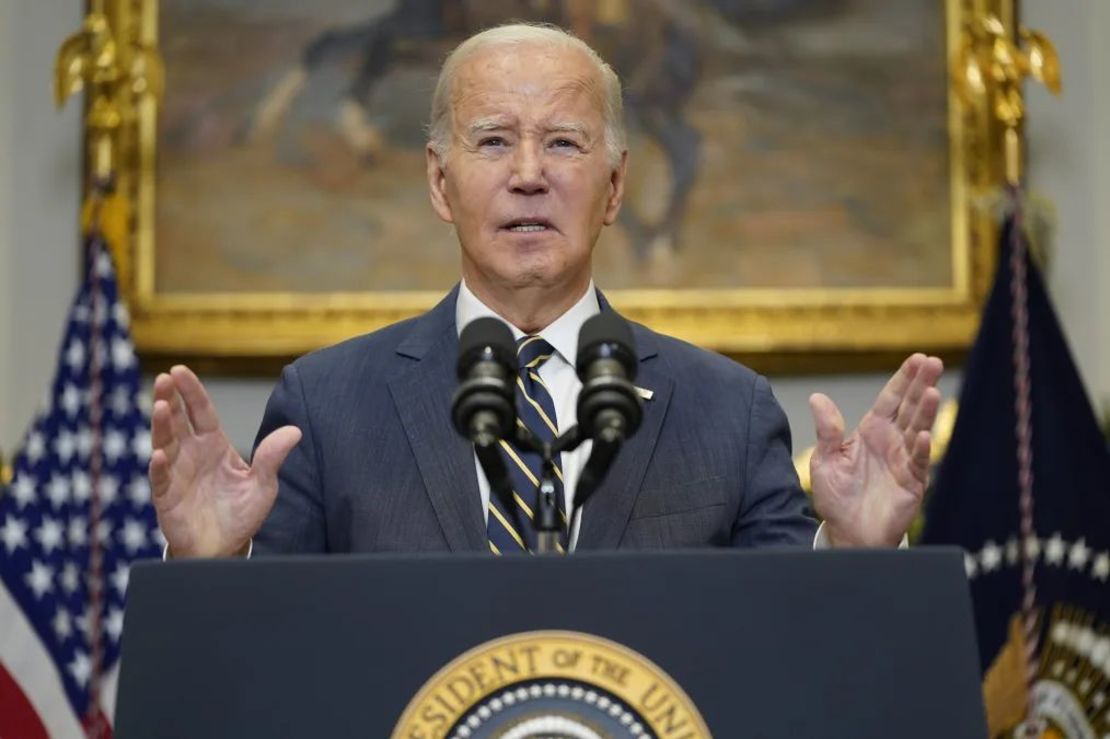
[389,287,487,551]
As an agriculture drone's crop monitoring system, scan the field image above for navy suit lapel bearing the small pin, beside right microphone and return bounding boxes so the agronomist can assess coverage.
[577,321,674,549]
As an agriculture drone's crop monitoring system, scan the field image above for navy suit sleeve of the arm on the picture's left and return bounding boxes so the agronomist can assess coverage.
[253,364,327,556]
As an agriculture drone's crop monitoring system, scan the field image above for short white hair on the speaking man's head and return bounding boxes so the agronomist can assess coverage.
[427,23,626,166]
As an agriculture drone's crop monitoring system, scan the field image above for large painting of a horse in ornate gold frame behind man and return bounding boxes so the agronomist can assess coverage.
[93,0,1013,368]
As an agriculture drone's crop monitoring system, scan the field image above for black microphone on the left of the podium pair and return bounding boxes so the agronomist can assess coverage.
[451,317,516,448]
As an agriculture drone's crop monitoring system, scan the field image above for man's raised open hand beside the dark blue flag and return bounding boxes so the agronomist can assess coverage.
[809,354,945,547]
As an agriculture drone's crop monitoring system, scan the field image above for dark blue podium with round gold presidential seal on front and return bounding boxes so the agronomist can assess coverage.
[117,549,986,739]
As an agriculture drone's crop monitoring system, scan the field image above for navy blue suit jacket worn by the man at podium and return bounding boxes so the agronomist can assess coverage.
[254,288,816,554]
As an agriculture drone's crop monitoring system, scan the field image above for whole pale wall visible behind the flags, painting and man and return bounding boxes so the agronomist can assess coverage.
[0,0,1110,451]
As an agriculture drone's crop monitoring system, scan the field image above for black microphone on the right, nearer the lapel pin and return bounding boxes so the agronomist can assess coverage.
[577,311,643,444]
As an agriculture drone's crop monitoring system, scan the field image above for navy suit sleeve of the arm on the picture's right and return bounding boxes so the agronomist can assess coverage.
[731,376,817,547]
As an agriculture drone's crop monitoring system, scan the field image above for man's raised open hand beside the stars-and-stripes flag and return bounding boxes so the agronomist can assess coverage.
[150,365,301,557]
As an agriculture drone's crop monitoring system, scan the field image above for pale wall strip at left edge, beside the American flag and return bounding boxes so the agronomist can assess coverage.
[0,0,84,454]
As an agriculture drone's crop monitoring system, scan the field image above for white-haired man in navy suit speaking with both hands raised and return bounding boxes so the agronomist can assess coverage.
[150,24,942,557]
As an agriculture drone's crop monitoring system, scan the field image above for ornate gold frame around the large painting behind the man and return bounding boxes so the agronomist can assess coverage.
[93,0,1015,372]
